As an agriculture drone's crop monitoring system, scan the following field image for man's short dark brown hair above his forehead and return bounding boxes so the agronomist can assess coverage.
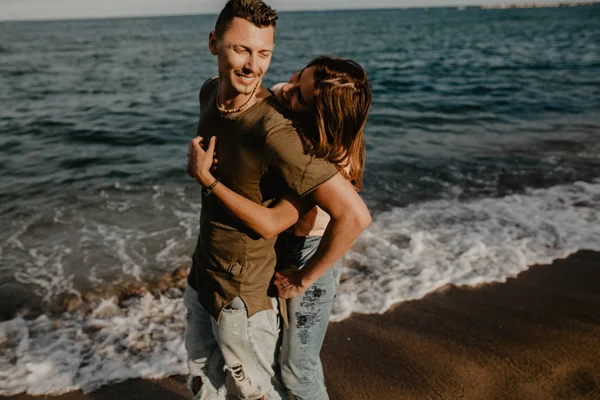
[215,0,277,37]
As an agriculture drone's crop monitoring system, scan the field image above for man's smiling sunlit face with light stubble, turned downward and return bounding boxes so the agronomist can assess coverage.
[209,18,275,98]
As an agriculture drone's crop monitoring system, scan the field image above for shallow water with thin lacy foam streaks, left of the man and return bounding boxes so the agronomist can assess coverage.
[0,185,200,304]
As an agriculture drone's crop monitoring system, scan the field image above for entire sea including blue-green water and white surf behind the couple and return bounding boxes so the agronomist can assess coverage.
[0,6,600,395]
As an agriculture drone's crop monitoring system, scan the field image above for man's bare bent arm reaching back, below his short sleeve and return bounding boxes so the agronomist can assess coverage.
[275,173,371,298]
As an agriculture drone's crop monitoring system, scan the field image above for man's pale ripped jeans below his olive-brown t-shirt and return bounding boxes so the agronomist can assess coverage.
[183,285,288,400]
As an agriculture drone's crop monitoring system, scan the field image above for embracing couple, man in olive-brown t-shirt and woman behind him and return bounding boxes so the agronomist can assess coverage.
[184,0,371,400]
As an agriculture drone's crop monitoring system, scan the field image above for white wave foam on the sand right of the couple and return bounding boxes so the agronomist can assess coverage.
[332,181,600,320]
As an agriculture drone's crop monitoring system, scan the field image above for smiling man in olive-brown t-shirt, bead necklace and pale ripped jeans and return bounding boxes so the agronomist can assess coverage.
[184,0,370,400]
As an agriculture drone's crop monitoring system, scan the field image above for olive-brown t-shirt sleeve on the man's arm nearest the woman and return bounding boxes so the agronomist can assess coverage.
[265,120,339,197]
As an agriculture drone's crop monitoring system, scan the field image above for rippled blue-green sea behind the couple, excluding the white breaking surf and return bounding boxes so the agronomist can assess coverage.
[0,6,600,317]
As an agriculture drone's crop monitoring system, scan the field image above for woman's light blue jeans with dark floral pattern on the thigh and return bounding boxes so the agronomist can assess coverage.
[277,233,339,400]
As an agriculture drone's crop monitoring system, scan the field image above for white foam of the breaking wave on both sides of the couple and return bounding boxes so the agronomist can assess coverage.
[0,181,600,395]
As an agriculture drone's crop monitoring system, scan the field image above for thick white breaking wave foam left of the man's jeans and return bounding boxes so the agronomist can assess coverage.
[0,292,187,395]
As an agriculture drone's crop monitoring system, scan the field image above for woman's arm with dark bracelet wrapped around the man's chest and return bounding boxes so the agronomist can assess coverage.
[187,136,314,239]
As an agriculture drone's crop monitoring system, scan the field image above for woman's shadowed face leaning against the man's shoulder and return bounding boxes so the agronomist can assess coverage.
[277,67,317,116]
